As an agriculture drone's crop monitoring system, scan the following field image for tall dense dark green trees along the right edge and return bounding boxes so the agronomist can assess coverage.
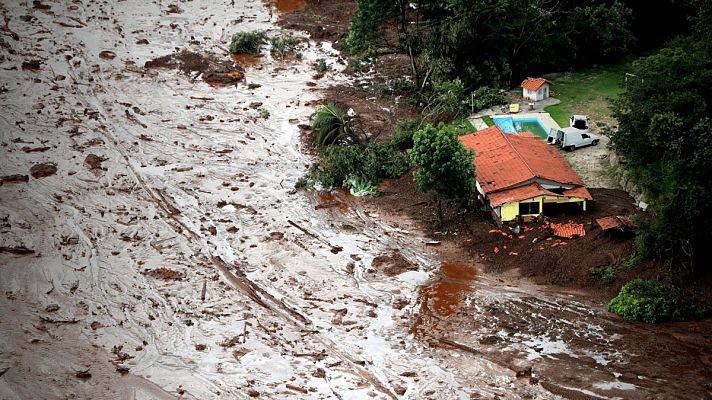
[612,11,712,272]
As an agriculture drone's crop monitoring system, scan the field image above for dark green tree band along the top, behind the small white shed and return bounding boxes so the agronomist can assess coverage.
[347,0,636,92]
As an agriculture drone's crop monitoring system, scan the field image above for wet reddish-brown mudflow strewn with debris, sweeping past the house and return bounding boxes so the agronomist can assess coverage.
[0,0,712,399]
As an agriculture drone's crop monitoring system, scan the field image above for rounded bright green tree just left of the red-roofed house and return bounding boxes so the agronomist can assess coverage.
[409,123,475,221]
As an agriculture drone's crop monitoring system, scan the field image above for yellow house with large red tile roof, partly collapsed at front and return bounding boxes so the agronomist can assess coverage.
[459,126,592,224]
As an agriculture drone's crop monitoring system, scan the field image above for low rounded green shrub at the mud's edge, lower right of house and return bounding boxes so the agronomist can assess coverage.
[608,278,701,324]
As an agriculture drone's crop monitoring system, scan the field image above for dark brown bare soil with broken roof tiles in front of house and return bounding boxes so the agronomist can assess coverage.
[364,173,662,299]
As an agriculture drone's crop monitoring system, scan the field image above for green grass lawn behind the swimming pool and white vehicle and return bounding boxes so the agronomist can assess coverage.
[544,59,631,127]
